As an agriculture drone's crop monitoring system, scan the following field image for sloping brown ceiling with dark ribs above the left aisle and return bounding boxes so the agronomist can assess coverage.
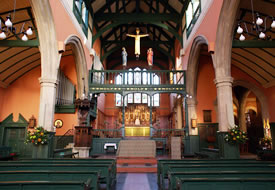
[0,0,40,88]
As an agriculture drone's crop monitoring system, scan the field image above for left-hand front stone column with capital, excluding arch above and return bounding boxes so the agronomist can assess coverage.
[38,78,57,131]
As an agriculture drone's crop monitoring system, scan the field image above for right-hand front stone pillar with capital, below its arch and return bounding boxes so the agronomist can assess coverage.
[214,76,234,132]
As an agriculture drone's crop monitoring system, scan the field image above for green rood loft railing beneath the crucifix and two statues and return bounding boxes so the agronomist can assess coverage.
[89,70,185,93]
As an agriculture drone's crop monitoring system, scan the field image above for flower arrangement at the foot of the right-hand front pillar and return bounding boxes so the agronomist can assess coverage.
[224,125,248,145]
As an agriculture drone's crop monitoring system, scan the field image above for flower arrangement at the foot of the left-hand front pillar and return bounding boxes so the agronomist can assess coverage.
[25,127,48,145]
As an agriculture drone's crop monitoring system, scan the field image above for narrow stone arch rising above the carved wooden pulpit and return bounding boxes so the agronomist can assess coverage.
[64,35,89,98]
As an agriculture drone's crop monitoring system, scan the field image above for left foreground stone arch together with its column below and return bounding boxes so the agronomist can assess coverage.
[30,0,59,131]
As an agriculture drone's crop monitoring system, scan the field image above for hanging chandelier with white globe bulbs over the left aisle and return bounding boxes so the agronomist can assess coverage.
[0,0,33,41]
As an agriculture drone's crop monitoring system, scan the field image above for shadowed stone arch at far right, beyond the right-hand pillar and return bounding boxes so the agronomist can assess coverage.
[233,80,269,135]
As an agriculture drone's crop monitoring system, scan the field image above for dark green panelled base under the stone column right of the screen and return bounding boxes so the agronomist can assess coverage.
[184,135,200,154]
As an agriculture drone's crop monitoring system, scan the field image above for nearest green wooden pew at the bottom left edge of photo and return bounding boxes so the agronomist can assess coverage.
[0,180,93,190]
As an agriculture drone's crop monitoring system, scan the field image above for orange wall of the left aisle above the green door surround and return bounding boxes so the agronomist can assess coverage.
[0,67,41,121]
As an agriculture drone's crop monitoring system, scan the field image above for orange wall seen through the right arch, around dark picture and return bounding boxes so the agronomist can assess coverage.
[197,55,217,123]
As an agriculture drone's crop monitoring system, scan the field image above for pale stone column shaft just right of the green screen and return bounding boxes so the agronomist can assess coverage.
[186,98,198,135]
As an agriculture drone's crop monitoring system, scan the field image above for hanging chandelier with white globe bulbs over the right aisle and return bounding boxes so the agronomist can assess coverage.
[237,0,275,41]
